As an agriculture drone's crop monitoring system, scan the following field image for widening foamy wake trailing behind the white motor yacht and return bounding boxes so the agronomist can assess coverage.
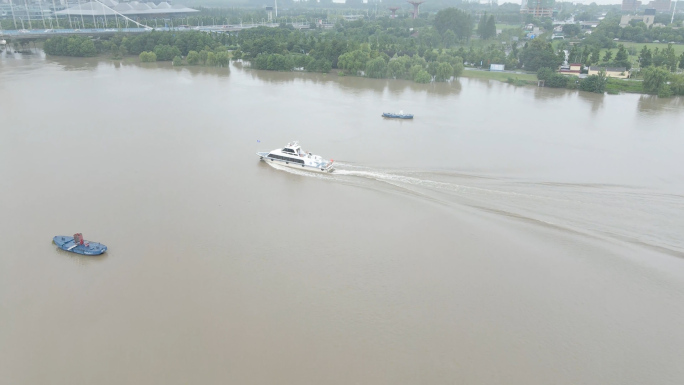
[331,164,684,257]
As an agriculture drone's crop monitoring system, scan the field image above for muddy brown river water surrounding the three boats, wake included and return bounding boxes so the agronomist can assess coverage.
[0,53,684,385]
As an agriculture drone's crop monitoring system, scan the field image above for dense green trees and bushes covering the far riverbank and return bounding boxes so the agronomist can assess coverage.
[30,4,684,92]
